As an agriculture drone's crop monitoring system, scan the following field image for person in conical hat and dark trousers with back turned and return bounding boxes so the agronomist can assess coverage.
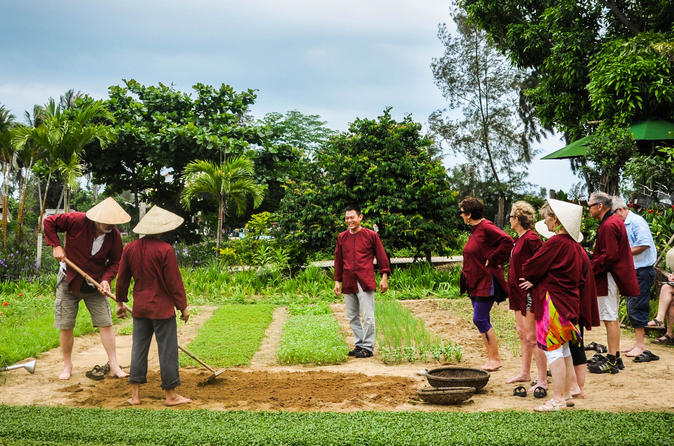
[116,206,191,406]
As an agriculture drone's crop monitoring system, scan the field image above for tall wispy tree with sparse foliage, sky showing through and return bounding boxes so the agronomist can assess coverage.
[429,12,540,223]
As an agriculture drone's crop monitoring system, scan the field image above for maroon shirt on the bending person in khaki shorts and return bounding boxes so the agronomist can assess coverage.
[44,212,122,294]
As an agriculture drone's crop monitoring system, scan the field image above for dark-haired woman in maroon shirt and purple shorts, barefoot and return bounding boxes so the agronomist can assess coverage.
[460,197,513,371]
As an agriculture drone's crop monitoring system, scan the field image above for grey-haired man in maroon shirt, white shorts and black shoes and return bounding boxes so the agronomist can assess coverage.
[587,192,639,373]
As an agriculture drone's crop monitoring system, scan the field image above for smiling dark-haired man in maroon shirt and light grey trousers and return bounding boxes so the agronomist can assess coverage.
[335,206,391,358]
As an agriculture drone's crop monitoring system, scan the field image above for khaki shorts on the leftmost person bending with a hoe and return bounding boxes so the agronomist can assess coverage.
[54,273,112,330]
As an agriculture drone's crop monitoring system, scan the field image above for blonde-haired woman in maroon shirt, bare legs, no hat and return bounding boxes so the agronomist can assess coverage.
[506,201,548,396]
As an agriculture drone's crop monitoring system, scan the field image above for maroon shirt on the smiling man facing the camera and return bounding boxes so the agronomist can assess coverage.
[335,227,391,294]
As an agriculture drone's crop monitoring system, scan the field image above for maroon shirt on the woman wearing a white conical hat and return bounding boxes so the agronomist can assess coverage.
[522,234,599,329]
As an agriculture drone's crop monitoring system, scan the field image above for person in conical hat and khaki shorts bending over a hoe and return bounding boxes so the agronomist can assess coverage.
[44,198,131,380]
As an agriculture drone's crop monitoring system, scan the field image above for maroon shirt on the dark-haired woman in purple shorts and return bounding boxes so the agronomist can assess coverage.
[461,219,513,297]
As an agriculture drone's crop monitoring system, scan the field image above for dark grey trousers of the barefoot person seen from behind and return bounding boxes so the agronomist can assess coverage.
[129,317,180,390]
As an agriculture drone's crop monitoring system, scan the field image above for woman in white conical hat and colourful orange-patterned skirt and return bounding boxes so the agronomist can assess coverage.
[520,199,599,412]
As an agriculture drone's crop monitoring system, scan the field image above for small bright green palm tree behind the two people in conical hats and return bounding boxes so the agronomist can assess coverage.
[180,156,264,252]
